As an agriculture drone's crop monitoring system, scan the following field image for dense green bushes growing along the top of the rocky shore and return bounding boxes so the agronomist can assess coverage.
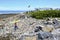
[26,8,60,19]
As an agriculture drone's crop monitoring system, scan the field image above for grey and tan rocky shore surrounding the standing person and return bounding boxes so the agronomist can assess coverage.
[0,14,60,40]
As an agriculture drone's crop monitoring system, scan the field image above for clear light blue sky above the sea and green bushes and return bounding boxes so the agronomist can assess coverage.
[0,0,60,10]
